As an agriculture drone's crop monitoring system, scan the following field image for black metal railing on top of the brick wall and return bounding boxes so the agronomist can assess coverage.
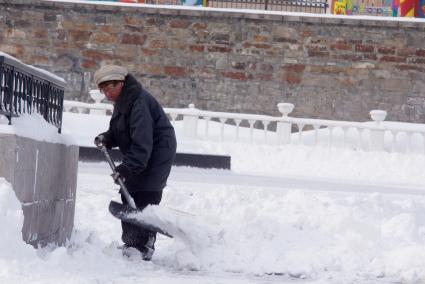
[207,0,328,14]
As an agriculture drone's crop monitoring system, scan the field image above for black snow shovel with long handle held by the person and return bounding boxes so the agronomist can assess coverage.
[95,143,173,238]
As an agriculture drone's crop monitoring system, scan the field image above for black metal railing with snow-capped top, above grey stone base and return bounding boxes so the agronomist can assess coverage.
[0,56,65,133]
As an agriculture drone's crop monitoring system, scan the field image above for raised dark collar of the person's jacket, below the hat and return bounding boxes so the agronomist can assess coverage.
[114,74,143,114]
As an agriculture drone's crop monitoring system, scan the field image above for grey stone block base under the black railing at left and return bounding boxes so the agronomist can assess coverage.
[0,134,78,247]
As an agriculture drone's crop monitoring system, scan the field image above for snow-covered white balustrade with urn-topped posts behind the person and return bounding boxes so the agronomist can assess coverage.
[64,90,425,153]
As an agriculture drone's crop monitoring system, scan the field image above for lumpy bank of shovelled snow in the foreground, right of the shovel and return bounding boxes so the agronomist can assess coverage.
[161,184,425,283]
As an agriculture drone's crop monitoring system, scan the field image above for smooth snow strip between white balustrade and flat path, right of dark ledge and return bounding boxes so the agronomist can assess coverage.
[229,144,425,186]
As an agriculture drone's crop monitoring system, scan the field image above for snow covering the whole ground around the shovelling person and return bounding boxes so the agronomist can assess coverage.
[0,113,425,284]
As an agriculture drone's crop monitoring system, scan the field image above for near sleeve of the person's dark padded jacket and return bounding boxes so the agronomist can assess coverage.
[117,98,154,179]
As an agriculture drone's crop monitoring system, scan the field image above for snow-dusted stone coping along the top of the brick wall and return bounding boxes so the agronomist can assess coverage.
[0,0,425,30]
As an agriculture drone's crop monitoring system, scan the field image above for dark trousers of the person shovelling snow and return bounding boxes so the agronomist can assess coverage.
[121,190,162,250]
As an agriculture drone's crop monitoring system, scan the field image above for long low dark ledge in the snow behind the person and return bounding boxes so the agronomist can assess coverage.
[79,147,231,170]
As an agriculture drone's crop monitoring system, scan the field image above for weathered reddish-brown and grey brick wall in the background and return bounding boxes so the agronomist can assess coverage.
[0,0,425,123]
